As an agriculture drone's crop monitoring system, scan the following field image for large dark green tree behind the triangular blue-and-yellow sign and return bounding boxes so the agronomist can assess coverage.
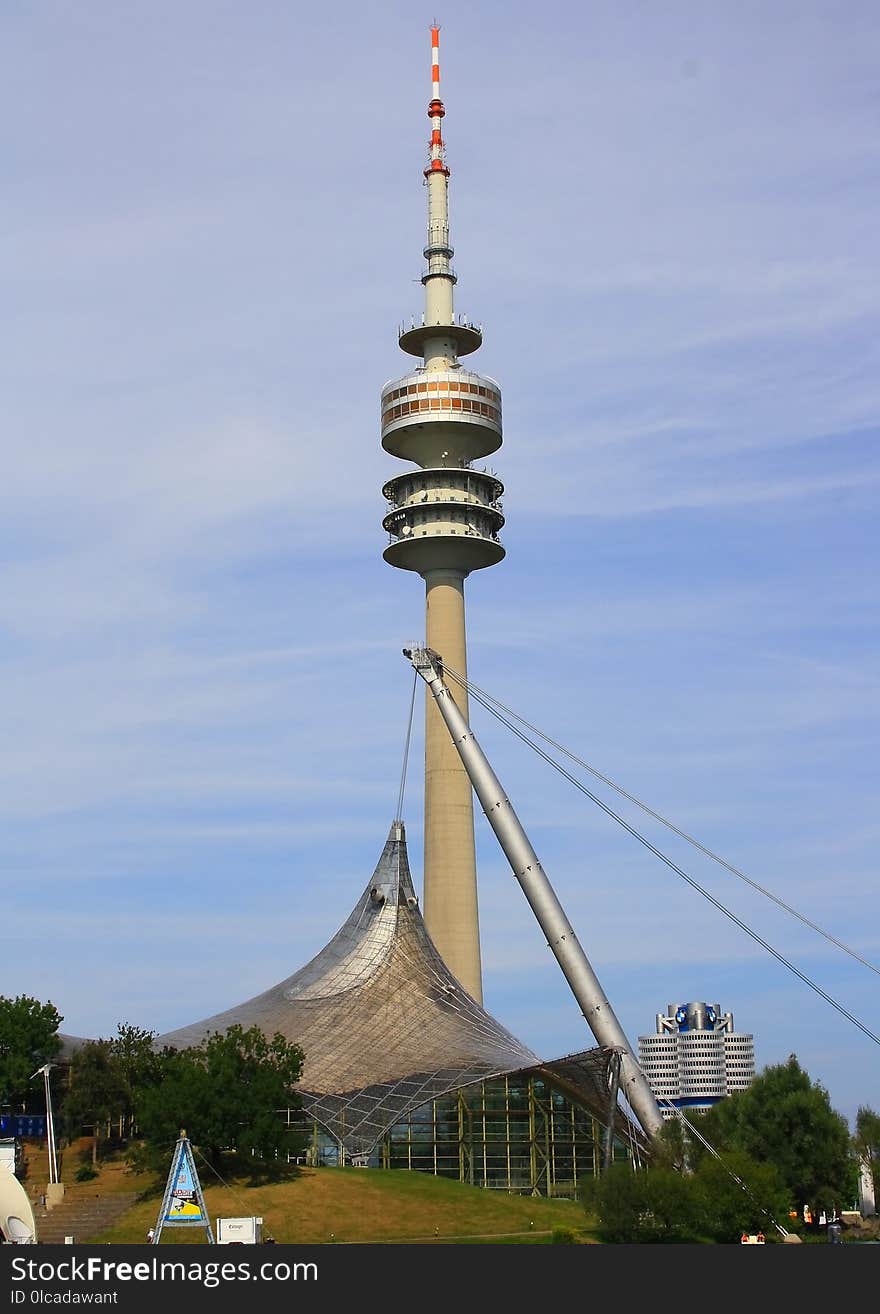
[135,1025,303,1176]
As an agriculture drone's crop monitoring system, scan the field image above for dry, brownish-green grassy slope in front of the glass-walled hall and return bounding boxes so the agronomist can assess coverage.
[48,1159,595,1244]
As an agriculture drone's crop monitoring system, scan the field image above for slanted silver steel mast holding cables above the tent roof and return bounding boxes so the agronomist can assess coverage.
[403,648,663,1139]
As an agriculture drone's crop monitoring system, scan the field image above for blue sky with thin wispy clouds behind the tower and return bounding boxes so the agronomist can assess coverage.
[0,0,880,1120]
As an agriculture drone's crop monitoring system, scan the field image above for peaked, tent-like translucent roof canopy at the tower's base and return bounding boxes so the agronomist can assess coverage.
[156,821,644,1160]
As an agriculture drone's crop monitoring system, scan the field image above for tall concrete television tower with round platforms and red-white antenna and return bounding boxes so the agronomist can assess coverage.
[382,25,504,1003]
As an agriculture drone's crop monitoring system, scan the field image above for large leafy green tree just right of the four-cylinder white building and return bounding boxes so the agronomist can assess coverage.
[693,1054,855,1210]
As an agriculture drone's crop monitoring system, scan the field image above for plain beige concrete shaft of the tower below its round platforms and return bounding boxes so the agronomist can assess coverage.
[424,570,482,1004]
